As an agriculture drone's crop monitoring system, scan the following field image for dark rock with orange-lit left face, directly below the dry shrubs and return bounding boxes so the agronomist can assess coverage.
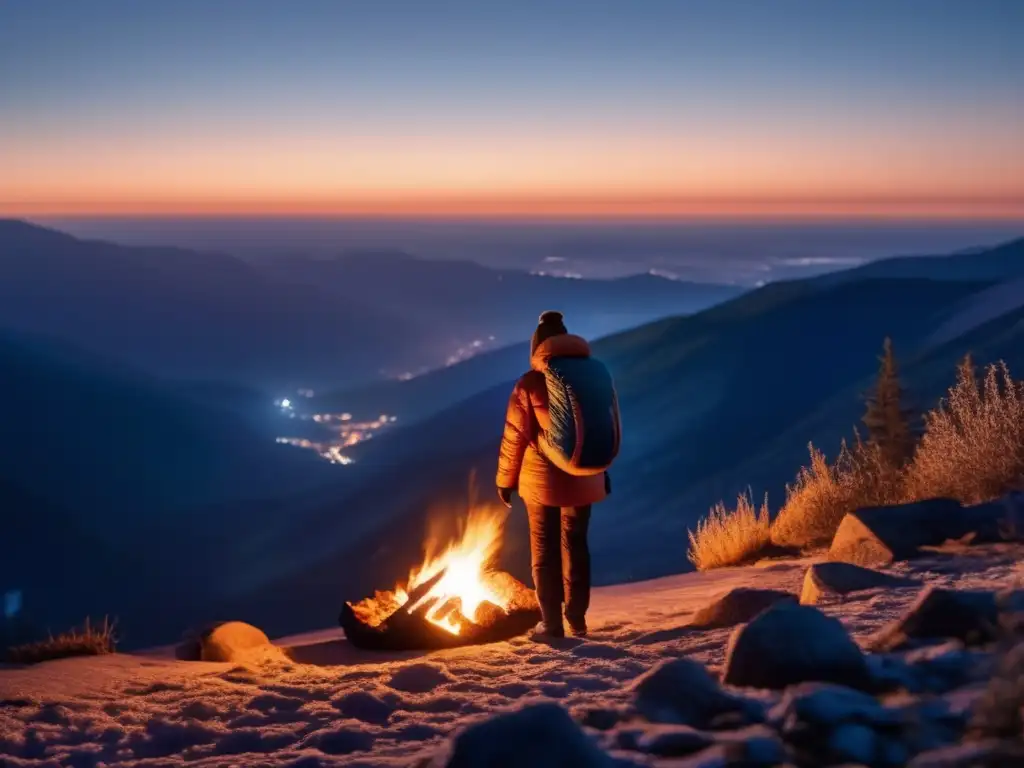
[828,499,962,566]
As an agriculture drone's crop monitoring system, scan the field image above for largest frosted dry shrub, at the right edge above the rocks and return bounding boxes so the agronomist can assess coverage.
[906,357,1024,504]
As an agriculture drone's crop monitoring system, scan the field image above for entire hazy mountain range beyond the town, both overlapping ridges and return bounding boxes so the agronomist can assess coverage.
[0,220,738,391]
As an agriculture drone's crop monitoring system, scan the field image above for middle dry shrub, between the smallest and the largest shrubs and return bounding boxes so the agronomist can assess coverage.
[771,437,902,548]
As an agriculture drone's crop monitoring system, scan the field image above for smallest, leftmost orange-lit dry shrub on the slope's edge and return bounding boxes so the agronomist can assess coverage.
[688,493,771,570]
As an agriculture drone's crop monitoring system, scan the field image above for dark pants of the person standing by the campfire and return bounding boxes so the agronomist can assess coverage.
[526,504,590,631]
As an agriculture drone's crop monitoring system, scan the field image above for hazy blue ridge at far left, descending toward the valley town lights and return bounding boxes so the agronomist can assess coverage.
[0,221,427,388]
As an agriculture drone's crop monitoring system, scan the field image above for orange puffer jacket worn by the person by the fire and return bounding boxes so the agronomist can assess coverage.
[497,334,606,507]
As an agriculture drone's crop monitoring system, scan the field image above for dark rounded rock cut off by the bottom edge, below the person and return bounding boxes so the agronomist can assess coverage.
[431,702,613,768]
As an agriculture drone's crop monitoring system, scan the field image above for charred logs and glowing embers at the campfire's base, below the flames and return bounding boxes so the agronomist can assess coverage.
[339,571,541,651]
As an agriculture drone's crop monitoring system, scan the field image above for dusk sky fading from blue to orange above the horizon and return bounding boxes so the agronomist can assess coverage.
[0,0,1024,218]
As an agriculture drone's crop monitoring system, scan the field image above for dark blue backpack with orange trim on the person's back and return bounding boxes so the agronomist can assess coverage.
[538,357,622,476]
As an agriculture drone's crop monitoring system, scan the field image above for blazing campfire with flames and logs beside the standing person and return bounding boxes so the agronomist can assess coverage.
[340,508,540,650]
